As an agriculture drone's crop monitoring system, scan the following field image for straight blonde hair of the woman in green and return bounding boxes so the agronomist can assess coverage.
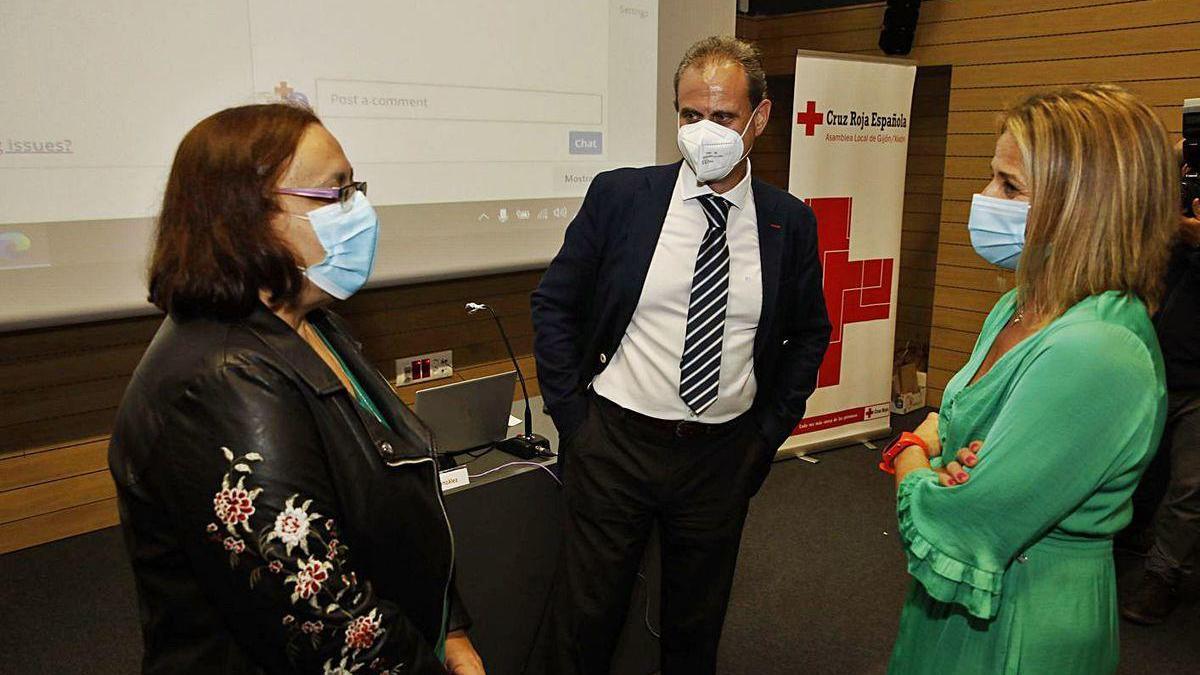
[1001,84,1180,319]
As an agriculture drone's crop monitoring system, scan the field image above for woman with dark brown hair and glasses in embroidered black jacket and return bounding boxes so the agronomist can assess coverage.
[109,104,484,675]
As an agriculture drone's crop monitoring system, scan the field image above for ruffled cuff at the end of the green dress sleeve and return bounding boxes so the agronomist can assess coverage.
[896,468,1004,619]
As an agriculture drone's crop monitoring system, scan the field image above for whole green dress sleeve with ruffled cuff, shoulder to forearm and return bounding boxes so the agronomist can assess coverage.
[896,321,1165,620]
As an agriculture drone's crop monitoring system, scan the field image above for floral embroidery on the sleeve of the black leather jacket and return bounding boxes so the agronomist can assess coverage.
[205,448,388,673]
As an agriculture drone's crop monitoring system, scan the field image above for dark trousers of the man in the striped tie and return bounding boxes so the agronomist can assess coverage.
[548,394,774,675]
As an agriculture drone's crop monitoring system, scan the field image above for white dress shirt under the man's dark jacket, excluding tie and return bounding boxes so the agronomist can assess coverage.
[592,162,762,424]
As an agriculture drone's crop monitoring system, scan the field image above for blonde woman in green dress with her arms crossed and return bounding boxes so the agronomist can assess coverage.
[882,85,1178,675]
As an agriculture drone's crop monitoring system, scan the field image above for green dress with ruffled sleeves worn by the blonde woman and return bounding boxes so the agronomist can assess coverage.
[888,291,1166,675]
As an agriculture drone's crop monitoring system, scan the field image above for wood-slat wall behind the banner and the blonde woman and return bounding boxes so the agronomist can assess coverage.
[743,0,1200,405]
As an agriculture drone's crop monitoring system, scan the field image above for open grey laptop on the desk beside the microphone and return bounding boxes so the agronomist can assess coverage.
[414,370,517,454]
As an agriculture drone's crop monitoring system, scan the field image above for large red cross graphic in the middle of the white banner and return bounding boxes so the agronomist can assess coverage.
[805,197,894,387]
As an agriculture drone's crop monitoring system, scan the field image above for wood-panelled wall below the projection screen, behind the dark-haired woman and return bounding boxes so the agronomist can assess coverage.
[0,265,541,554]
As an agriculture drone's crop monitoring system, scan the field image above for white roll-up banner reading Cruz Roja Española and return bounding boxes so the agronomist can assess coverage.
[784,50,917,452]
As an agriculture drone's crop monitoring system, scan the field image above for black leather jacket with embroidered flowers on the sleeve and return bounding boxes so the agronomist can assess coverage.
[108,306,467,674]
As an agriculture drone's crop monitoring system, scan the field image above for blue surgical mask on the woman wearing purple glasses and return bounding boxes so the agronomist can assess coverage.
[296,187,379,295]
